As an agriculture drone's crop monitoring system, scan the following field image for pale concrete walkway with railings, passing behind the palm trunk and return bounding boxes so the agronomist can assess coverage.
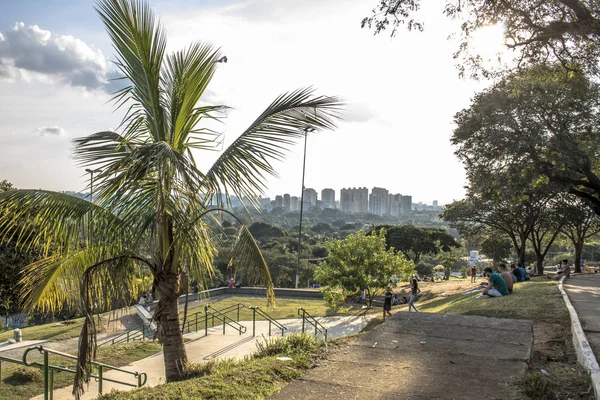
[34,315,375,400]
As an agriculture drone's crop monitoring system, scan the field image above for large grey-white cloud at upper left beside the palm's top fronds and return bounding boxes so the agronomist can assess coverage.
[0,22,118,89]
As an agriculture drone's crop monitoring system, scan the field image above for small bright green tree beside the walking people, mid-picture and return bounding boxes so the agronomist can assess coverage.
[315,230,414,305]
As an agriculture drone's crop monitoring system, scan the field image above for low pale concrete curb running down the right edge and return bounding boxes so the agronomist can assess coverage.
[558,277,600,399]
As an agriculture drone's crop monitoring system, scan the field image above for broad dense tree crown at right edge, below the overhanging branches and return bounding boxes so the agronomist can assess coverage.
[452,65,600,213]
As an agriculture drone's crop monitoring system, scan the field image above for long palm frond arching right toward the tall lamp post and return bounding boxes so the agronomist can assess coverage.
[206,88,342,206]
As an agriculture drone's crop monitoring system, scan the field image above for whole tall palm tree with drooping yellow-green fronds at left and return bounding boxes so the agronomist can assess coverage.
[0,0,341,398]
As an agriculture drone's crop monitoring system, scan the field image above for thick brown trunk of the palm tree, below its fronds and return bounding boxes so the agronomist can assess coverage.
[156,273,187,382]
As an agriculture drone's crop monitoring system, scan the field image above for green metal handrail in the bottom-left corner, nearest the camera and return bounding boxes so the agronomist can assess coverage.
[22,346,148,400]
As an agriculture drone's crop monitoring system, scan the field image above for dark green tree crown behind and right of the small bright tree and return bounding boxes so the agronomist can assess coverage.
[371,225,460,264]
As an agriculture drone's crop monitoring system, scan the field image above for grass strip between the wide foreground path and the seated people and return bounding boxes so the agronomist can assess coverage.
[415,278,569,322]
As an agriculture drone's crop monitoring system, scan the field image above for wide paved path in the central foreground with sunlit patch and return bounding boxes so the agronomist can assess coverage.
[271,312,533,400]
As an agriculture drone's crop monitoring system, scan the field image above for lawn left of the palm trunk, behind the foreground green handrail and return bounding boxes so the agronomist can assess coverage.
[0,341,162,400]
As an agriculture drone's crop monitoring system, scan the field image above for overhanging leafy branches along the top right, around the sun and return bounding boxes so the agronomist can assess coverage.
[362,0,600,76]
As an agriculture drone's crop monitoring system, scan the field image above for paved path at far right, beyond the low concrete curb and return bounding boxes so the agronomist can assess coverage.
[563,274,600,360]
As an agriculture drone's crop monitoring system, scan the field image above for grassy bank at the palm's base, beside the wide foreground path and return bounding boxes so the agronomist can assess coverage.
[101,335,332,400]
